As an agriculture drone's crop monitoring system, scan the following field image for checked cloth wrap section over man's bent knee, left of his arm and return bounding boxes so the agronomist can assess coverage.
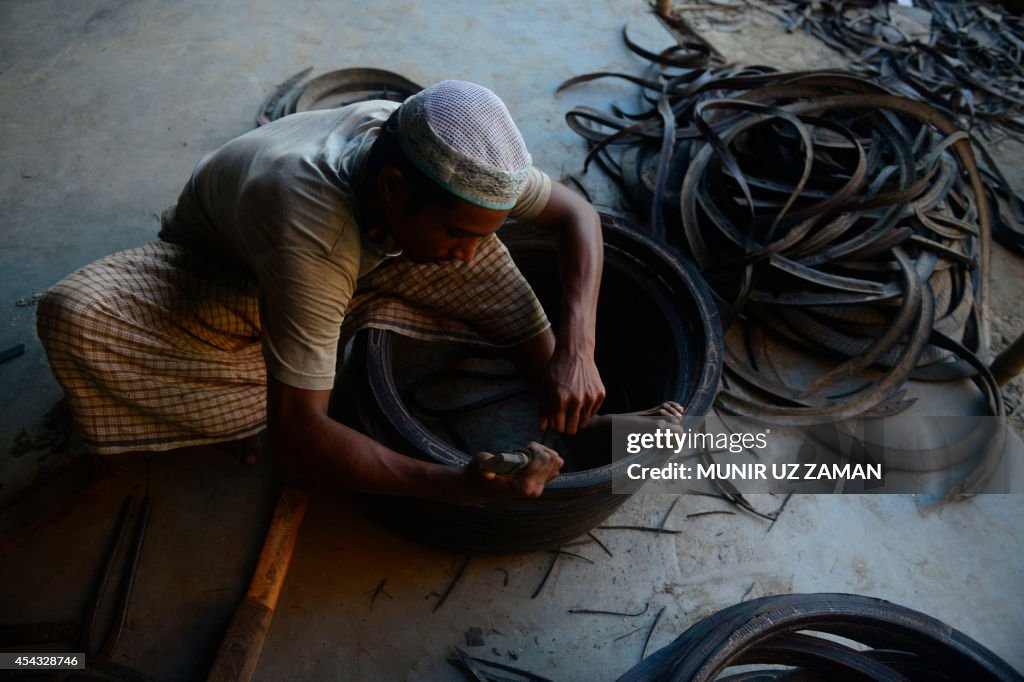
[37,242,266,455]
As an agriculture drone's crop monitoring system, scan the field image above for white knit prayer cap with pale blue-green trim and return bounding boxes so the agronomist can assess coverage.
[398,81,531,210]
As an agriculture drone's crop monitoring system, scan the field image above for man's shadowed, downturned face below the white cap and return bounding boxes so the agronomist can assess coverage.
[385,174,509,265]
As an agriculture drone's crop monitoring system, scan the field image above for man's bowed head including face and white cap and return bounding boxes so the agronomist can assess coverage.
[368,81,530,263]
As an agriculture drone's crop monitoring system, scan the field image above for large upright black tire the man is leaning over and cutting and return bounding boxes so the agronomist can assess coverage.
[345,216,722,553]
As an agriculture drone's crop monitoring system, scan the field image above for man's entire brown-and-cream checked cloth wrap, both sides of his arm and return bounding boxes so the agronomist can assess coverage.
[37,233,549,455]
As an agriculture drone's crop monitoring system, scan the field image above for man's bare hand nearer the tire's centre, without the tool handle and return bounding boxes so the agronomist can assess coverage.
[540,344,604,435]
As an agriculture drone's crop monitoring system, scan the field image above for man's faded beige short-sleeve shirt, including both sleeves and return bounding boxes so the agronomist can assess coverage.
[161,101,551,390]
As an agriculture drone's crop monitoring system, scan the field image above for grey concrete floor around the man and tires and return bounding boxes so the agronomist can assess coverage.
[0,0,1024,680]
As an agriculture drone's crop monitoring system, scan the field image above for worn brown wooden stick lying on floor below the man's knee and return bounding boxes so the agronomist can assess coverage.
[207,487,309,682]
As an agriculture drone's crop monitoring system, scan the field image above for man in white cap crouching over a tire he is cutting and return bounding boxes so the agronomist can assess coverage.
[38,81,604,504]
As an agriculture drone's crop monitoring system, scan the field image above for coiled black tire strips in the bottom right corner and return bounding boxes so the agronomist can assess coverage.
[618,593,1024,682]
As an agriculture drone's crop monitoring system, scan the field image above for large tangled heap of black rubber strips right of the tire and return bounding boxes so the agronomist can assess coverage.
[559,13,1022,495]
